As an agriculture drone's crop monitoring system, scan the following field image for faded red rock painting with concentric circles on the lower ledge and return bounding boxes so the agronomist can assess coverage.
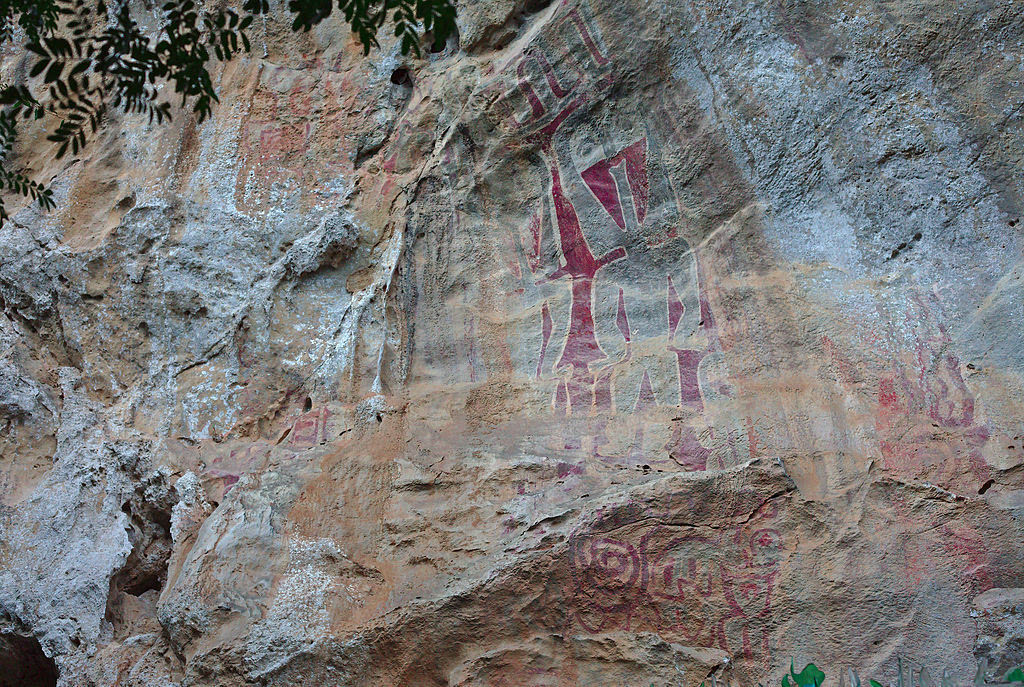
[568,502,782,660]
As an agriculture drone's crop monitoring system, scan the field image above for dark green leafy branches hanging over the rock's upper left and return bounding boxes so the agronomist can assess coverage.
[0,0,456,223]
